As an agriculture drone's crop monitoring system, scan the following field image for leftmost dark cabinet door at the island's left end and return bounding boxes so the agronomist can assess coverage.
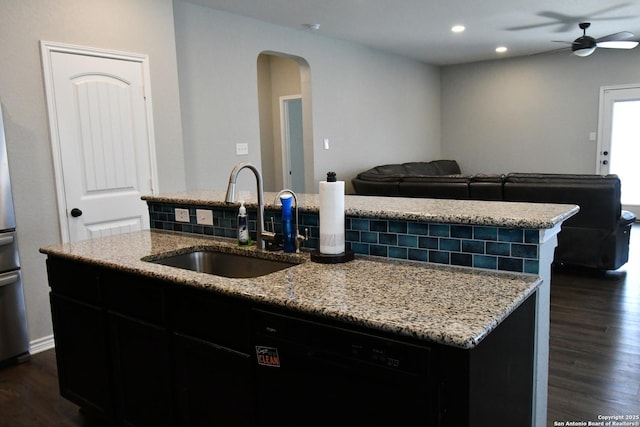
[50,293,111,418]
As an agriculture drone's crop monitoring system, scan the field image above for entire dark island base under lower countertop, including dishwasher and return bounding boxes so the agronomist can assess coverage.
[47,257,536,427]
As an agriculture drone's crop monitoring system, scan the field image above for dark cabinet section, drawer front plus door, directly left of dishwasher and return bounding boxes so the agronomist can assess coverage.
[170,288,254,427]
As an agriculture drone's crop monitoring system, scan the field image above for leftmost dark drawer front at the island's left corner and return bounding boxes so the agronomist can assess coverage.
[47,257,102,305]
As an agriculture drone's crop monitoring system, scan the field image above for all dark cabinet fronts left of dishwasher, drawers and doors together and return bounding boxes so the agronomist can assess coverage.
[47,257,254,427]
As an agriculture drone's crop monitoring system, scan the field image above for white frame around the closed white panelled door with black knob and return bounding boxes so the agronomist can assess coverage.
[40,40,158,243]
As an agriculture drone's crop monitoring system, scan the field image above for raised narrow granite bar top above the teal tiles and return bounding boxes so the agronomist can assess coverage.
[142,190,579,229]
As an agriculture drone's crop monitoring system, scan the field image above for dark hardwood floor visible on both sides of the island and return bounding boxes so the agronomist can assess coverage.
[0,224,640,427]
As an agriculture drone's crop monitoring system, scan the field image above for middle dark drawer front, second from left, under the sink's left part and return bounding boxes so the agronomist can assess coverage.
[100,270,166,325]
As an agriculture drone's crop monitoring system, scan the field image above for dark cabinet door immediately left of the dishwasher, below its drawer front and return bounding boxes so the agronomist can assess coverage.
[174,334,254,427]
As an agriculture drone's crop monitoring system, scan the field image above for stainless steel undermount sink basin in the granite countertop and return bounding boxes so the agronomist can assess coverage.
[149,250,297,279]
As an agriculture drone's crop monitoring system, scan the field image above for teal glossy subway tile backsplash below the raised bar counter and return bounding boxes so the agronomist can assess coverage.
[148,202,539,274]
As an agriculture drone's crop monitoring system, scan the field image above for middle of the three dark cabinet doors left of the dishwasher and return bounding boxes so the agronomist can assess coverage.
[109,313,173,427]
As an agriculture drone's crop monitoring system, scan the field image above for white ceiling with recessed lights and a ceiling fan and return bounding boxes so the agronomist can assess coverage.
[180,0,640,65]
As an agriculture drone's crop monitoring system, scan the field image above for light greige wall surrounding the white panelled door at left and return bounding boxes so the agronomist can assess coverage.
[0,0,185,341]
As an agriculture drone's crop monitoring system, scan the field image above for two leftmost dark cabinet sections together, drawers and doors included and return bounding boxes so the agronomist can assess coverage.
[47,258,173,427]
